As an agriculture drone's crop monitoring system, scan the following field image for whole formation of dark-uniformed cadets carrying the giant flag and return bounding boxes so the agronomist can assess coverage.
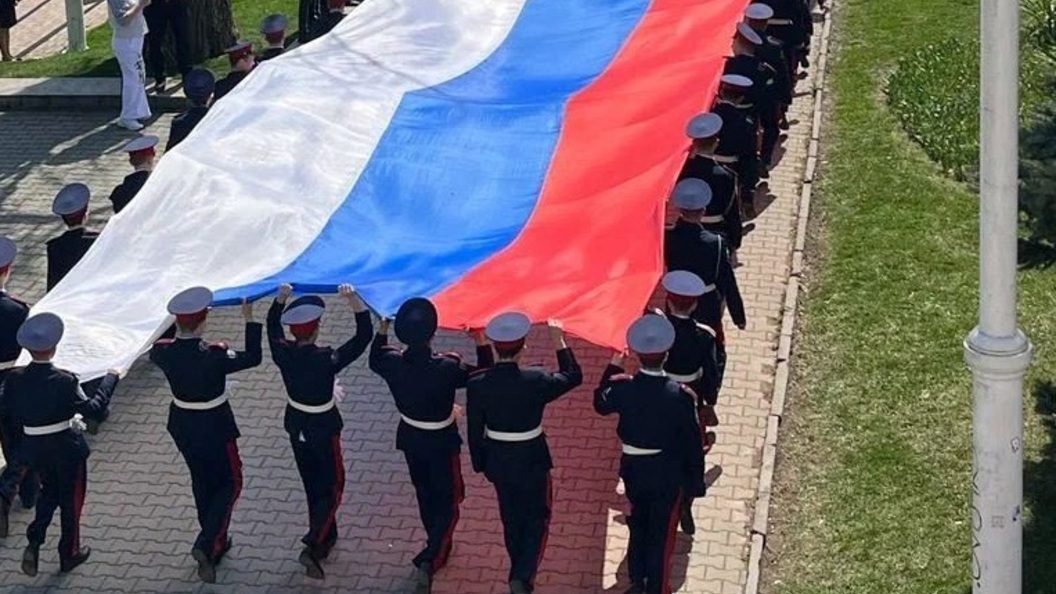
[0,0,810,594]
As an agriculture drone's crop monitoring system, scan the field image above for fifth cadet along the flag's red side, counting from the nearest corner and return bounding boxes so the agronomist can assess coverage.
[712,74,759,211]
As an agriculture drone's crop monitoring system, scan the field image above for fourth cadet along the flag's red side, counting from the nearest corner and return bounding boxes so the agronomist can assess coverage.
[678,113,744,257]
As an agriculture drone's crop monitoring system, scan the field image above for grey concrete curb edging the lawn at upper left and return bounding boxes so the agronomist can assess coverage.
[0,78,187,111]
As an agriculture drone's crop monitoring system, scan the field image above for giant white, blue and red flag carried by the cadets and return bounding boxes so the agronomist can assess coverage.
[28,0,746,379]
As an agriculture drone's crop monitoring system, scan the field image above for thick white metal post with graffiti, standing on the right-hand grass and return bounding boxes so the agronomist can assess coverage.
[964,0,1033,594]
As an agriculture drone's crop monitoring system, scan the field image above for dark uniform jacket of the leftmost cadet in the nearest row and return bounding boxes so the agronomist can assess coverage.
[0,363,117,466]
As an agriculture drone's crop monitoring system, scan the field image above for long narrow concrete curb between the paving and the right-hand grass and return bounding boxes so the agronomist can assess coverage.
[744,8,832,594]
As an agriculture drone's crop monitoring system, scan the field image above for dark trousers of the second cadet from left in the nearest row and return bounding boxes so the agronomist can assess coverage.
[176,440,242,562]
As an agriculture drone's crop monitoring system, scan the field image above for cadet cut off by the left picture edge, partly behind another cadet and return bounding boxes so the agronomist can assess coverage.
[0,237,39,538]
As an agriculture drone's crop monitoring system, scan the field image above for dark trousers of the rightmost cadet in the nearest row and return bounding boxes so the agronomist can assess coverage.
[624,480,682,594]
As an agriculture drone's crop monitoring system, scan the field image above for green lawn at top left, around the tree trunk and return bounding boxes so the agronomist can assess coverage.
[0,0,298,78]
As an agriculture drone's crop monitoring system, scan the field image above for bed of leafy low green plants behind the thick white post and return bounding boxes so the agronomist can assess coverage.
[886,38,1056,182]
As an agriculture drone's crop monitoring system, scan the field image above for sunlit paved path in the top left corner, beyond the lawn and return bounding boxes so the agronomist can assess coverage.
[11,0,107,60]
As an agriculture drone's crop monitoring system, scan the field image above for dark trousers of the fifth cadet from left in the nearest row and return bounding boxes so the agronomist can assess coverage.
[494,470,553,588]
